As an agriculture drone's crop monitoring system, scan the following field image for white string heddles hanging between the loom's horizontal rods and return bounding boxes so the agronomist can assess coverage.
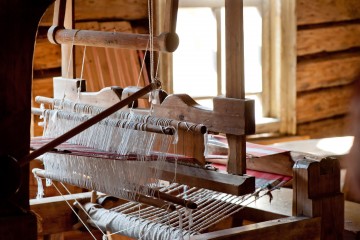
[44,108,174,200]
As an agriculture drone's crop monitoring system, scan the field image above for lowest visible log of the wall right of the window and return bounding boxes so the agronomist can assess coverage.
[297,115,352,138]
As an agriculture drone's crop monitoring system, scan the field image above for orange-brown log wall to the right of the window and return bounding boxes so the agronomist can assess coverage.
[296,0,360,138]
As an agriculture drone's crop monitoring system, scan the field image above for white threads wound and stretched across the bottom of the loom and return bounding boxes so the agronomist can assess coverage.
[79,183,284,240]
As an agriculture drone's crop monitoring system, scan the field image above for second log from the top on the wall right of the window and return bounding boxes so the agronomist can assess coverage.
[297,23,360,56]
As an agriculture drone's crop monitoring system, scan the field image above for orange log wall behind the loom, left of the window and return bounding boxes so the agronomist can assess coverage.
[33,0,148,136]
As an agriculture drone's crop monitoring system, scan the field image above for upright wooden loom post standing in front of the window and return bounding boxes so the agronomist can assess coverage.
[225,0,246,175]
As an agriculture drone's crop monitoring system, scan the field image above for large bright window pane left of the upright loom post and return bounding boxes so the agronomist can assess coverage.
[173,8,217,96]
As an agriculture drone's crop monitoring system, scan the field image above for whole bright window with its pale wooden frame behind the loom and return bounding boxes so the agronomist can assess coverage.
[158,0,296,133]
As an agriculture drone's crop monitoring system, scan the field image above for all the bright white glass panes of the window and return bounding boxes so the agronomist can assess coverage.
[173,4,262,117]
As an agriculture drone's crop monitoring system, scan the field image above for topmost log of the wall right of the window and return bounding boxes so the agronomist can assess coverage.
[296,0,360,25]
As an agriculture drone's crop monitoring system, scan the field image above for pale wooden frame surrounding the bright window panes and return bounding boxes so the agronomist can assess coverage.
[157,0,296,134]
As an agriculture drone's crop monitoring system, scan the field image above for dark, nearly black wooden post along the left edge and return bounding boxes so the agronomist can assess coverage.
[0,0,52,240]
